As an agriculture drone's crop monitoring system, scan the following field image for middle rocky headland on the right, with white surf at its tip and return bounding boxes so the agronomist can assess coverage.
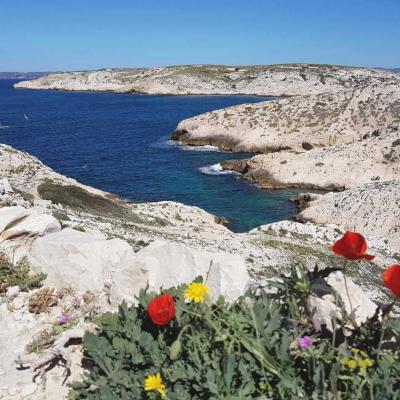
[221,130,400,190]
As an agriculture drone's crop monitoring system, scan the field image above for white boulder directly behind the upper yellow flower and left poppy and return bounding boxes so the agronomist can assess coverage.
[111,240,250,300]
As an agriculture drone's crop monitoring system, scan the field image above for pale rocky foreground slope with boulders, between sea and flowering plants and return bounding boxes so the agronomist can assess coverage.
[0,145,400,400]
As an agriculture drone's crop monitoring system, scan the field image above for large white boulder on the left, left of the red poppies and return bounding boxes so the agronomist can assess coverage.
[28,228,135,291]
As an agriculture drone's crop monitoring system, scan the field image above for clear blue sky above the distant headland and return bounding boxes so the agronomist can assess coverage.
[0,0,400,71]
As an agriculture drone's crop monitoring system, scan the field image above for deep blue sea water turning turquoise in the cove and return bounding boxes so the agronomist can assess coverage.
[0,80,298,232]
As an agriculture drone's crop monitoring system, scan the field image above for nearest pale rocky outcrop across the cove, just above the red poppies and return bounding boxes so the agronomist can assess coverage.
[298,181,400,251]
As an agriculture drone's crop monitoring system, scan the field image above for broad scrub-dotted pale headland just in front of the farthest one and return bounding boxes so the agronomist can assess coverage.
[172,81,400,153]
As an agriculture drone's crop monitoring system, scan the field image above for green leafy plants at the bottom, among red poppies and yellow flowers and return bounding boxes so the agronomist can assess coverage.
[69,268,400,400]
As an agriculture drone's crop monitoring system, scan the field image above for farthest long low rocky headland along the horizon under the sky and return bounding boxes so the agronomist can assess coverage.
[15,64,398,96]
